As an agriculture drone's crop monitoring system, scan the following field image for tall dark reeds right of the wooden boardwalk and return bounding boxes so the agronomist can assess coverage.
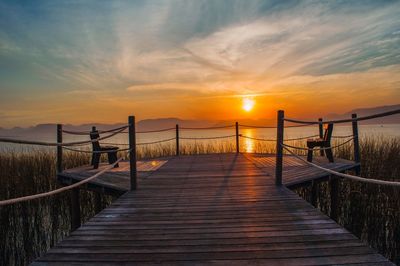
[294,136,400,264]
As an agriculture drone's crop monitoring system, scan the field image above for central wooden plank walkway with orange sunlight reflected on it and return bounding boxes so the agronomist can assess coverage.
[33,154,391,265]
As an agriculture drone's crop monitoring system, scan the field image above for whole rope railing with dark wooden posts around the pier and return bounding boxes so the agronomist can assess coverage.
[0,109,400,229]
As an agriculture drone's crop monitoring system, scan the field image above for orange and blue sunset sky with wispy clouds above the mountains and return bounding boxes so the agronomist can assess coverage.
[0,0,400,127]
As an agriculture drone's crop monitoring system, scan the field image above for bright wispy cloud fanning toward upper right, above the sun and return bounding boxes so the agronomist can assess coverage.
[185,1,400,80]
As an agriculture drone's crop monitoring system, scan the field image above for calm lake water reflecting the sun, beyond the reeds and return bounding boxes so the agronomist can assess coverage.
[0,124,400,152]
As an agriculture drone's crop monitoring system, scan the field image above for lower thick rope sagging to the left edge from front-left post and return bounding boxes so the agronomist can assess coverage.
[0,158,122,206]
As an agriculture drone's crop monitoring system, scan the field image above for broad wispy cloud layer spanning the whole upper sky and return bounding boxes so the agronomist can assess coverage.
[0,1,400,89]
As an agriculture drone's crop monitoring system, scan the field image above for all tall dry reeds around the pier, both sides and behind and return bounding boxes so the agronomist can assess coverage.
[0,137,400,265]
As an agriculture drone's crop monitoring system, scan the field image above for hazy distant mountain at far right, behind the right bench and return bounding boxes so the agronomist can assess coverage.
[324,104,400,124]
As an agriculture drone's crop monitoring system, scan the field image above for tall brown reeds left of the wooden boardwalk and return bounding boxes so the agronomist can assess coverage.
[0,149,117,265]
